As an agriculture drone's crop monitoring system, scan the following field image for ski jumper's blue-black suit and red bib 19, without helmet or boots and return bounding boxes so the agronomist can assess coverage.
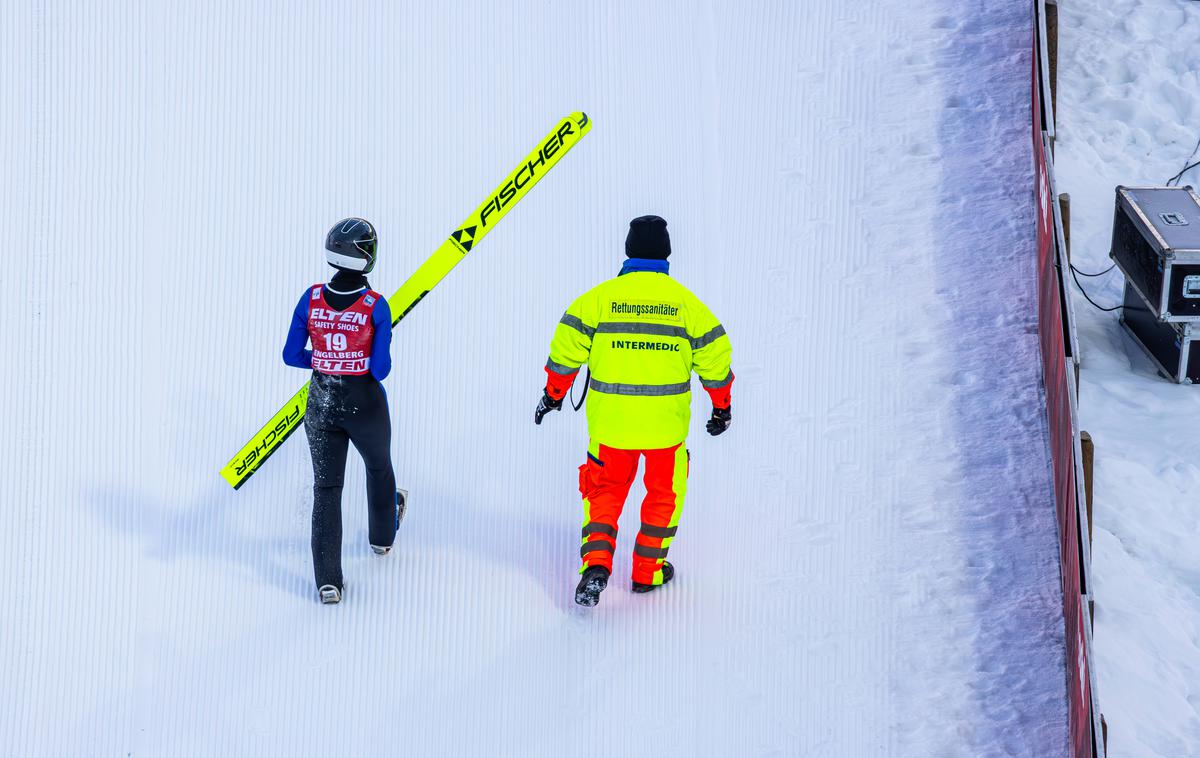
[283,272,396,589]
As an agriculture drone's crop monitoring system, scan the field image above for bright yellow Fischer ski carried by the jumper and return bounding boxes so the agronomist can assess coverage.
[221,113,592,489]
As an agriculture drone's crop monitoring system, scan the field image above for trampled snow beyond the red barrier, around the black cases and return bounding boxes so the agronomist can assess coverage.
[1056,0,1200,757]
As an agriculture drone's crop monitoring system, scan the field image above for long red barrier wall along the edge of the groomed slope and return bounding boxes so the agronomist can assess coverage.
[1031,4,1096,758]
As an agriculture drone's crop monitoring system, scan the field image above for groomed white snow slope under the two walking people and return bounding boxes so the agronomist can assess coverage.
[0,0,1066,758]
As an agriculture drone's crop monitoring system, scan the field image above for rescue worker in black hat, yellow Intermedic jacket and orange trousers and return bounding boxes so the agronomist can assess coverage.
[534,216,733,607]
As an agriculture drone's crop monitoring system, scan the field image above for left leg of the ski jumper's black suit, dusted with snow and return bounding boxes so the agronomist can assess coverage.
[305,420,350,589]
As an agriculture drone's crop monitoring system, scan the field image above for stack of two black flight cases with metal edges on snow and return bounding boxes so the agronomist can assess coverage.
[1109,187,1200,384]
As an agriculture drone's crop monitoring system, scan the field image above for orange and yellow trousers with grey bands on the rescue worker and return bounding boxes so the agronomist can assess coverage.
[580,440,689,584]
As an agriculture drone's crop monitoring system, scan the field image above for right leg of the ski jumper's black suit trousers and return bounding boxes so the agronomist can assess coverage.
[348,381,396,547]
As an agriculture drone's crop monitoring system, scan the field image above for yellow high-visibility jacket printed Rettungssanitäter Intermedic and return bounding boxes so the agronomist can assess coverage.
[546,271,733,450]
